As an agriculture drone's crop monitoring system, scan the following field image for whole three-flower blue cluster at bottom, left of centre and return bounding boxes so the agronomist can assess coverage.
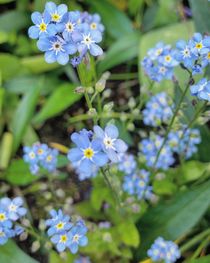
[45,210,88,254]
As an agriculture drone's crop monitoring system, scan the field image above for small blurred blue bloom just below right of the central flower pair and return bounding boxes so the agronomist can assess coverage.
[118,153,137,174]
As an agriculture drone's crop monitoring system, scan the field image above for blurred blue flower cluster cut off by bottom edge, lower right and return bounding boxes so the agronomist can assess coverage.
[147,237,181,263]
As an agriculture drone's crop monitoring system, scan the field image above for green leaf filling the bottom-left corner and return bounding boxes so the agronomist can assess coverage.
[0,240,39,263]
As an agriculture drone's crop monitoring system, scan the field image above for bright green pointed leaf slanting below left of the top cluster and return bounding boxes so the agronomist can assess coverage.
[33,84,81,124]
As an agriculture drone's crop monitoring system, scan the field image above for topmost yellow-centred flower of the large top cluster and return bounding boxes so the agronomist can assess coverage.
[45,2,68,23]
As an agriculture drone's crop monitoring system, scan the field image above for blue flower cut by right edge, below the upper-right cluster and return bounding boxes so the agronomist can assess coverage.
[190,78,210,101]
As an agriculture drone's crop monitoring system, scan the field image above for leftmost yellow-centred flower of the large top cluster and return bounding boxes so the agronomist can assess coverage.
[28,12,57,39]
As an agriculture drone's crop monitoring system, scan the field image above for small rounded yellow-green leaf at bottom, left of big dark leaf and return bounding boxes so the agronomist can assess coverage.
[117,220,140,247]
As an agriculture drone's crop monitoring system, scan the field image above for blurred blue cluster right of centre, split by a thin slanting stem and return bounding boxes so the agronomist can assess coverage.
[140,134,175,170]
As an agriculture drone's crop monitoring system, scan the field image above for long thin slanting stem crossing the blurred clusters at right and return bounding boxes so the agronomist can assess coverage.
[152,83,190,170]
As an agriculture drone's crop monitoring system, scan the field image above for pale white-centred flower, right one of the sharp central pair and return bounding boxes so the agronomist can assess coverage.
[93,124,128,163]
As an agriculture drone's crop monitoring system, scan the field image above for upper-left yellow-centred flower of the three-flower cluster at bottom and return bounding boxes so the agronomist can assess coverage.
[45,210,73,236]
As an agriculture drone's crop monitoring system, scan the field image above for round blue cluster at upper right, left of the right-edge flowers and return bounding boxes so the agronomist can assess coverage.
[141,42,179,82]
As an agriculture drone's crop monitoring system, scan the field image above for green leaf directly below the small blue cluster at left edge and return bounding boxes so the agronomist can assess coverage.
[3,160,39,186]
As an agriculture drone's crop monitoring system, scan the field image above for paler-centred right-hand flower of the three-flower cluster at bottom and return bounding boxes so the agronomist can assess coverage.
[69,225,88,254]
